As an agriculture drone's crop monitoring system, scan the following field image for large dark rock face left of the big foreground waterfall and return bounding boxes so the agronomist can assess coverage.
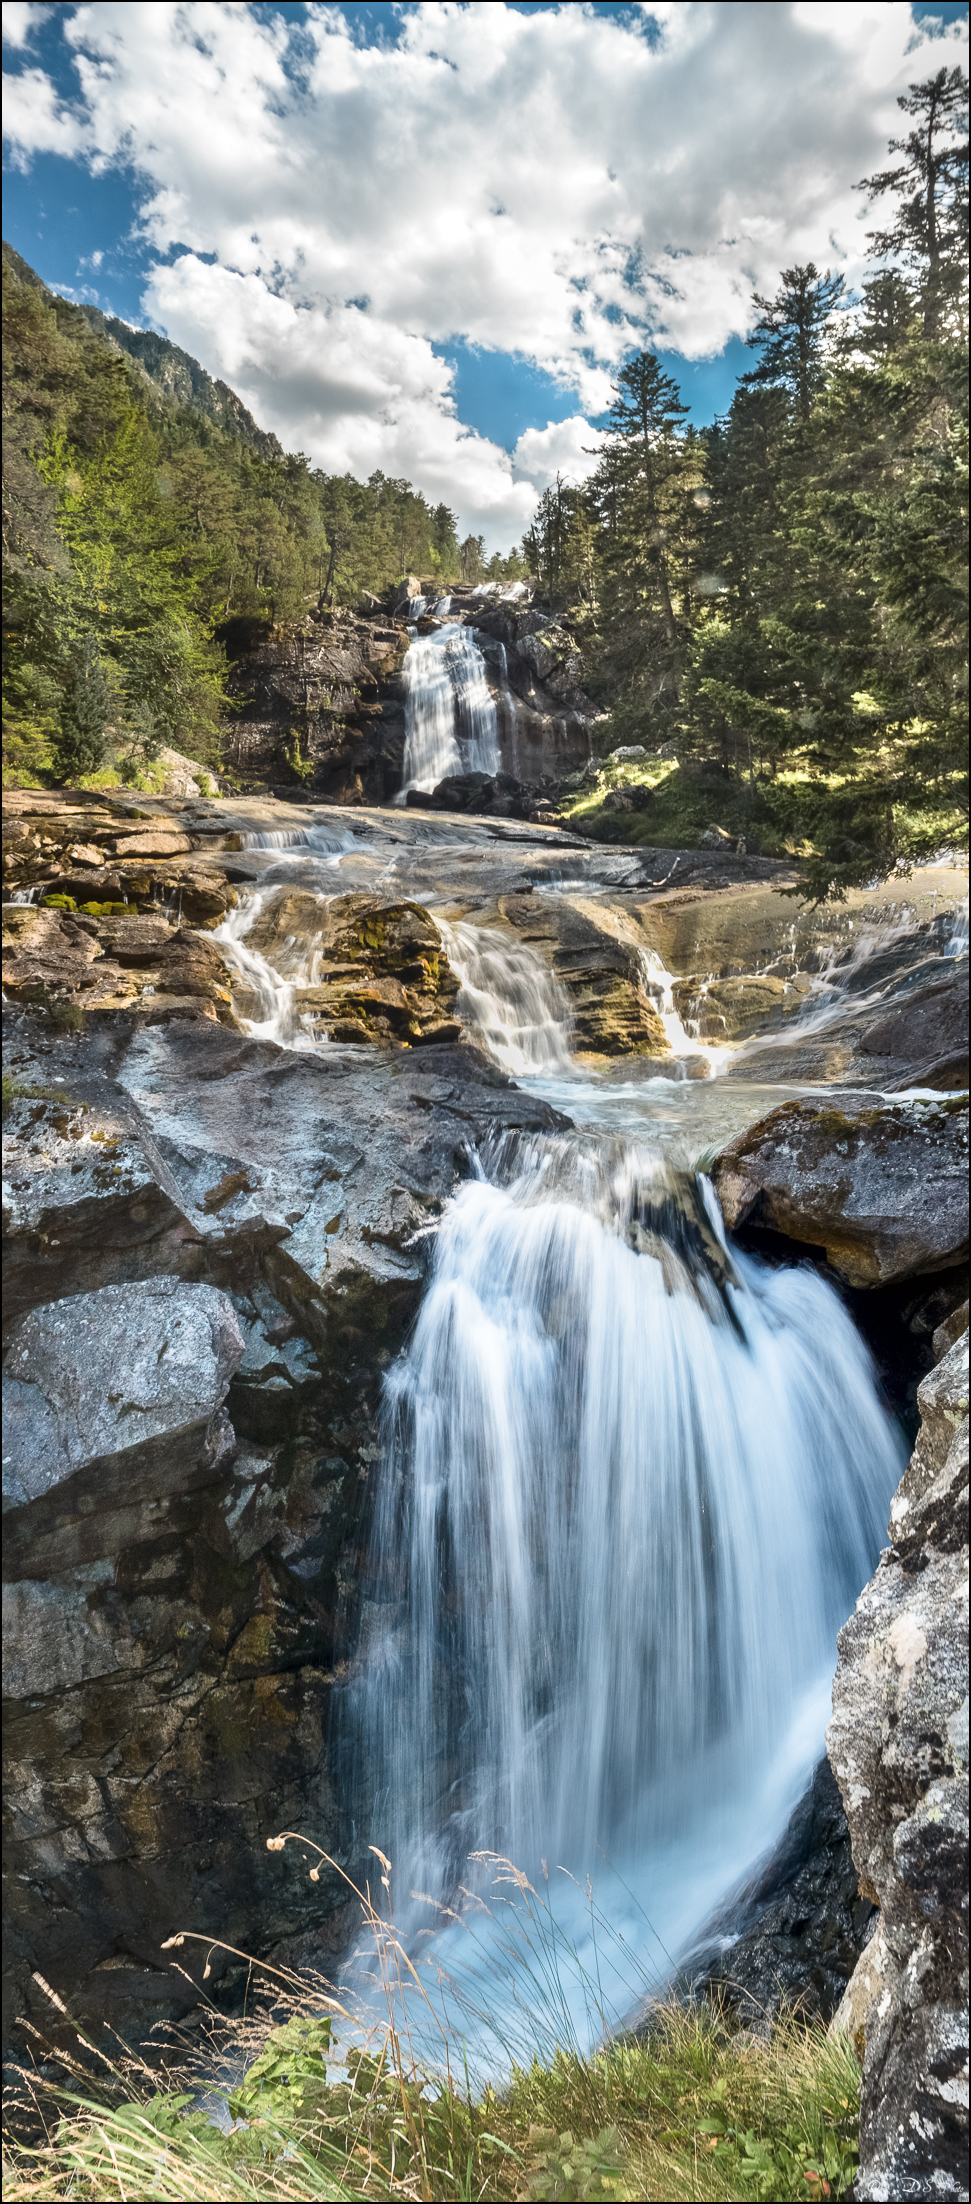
[4,1012,561,2041]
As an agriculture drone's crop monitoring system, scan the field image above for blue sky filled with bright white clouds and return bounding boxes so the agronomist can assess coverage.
[2,0,967,551]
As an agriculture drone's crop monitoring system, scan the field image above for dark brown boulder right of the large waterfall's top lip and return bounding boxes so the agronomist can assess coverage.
[711,1093,969,1287]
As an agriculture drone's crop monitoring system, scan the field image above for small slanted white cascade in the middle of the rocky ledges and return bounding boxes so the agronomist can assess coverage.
[436,919,570,1078]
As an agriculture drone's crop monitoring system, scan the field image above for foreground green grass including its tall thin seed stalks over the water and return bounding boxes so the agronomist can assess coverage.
[4,1838,859,2204]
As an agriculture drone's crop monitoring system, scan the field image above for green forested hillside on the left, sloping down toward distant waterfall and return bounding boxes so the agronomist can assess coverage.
[2,245,520,780]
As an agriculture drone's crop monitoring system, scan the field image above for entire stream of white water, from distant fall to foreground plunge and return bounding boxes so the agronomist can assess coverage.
[216,626,960,2072]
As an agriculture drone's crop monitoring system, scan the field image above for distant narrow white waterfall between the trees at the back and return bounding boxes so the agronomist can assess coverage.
[401,622,500,800]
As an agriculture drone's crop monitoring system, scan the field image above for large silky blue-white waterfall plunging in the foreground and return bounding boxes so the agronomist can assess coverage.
[346,1135,903,2034]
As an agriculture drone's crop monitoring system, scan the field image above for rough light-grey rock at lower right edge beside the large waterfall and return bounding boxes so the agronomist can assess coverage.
[828,1307,969,2200]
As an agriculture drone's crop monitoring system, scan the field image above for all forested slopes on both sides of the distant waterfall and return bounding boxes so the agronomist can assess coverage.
[2,68,969,895]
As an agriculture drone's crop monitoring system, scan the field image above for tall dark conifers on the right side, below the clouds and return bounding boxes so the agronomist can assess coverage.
[537,68,969,890]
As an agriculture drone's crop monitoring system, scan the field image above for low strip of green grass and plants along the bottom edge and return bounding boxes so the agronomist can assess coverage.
[4,1992,859,2204]
